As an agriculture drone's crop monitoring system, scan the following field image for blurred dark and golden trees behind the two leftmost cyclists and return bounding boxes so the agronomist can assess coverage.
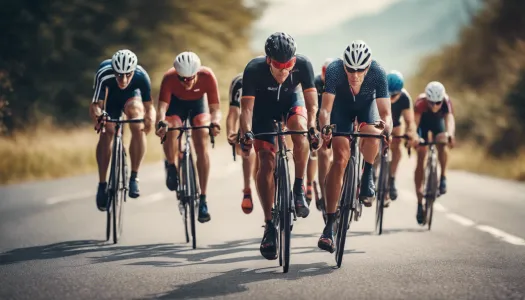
[0,0,265,133]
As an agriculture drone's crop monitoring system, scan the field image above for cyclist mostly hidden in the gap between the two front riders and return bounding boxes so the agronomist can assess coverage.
[306,58,333,210]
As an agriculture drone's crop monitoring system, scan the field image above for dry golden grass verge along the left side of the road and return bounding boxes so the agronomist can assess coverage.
[0,102,228,185]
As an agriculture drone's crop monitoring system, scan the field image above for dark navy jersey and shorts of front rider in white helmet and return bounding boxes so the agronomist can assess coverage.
[325,59,389,132]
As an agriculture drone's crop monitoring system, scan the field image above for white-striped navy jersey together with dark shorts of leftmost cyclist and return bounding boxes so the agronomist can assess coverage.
[92,59,151,119]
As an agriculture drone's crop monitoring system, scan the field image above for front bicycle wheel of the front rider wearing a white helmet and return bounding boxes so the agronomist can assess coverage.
[335,156,356,268]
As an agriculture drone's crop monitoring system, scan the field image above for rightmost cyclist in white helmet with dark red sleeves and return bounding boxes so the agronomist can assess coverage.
[414,81,456,224]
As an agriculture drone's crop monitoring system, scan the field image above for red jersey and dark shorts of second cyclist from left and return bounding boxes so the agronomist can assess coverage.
[159,66,219,126]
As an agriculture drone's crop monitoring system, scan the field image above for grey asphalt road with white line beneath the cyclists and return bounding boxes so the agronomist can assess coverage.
[0,147,525,300]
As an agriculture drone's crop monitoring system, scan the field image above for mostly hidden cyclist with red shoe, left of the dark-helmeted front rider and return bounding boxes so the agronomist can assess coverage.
[226,73,256,214]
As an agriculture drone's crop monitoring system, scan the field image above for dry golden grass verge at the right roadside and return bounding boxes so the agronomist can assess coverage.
[450,144,525,181]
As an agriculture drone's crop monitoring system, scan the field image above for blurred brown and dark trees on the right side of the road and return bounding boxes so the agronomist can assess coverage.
[410,0,525,157]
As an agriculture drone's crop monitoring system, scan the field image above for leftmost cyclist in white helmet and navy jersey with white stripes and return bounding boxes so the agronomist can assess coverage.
[90,49,155,211]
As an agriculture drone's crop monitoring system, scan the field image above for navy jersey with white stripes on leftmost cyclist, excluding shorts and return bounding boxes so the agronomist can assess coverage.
[93,59,151,102]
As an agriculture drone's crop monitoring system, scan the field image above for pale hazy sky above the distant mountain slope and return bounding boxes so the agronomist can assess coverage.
[257,0,403,35]
